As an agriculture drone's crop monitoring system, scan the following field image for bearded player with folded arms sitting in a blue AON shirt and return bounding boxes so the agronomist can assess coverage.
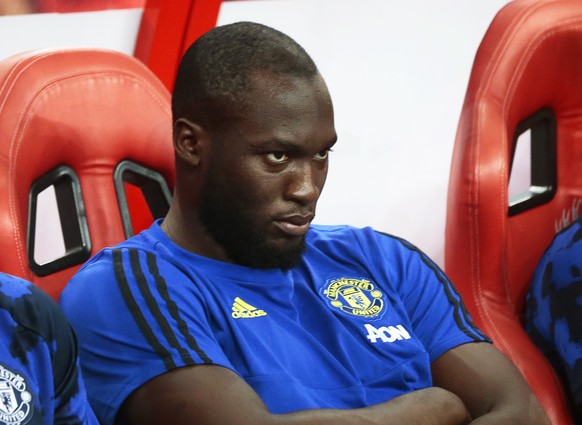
[61,22,547,425]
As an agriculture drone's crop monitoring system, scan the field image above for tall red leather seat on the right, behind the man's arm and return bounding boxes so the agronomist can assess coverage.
[445,0,582,425]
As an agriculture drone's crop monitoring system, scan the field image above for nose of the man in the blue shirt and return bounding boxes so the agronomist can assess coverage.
[285,161,327,205]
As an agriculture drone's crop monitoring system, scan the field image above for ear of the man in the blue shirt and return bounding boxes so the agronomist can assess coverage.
[173,118,210,166]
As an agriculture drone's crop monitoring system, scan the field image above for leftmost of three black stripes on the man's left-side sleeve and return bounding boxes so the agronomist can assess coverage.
[113,249,176,370]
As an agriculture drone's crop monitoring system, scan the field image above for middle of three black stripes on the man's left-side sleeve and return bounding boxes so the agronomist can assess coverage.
[129,249,194,365]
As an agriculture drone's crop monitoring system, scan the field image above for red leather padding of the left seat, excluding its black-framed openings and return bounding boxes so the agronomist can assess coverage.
[0,49,174,296]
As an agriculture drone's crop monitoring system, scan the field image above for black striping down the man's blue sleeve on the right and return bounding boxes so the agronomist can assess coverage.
[378,232,491,341]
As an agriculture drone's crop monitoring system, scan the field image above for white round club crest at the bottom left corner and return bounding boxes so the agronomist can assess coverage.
[0,364,32,425]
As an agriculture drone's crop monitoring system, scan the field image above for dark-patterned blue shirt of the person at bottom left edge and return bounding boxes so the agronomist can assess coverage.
[0,273,97,425]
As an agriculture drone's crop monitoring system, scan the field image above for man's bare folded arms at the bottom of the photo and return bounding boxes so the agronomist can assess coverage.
[118,343,549,425]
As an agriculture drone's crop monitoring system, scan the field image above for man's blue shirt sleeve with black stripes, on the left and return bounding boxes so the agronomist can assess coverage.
[61,248,233,424]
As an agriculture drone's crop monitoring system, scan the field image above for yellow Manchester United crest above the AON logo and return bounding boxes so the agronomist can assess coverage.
[323,277,384,318]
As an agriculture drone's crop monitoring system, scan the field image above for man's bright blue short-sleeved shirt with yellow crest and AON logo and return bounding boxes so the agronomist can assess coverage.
[61,222,487,425]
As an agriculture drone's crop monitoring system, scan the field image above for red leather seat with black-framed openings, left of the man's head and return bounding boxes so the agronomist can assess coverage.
[0,49,174,299]
